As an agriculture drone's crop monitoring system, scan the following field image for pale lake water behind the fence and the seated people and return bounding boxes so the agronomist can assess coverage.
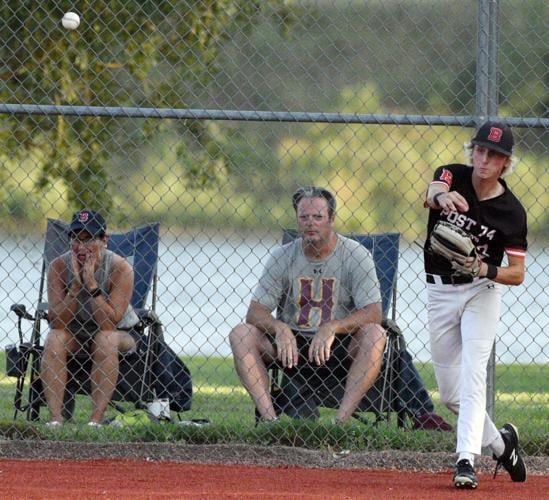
[0,235,549,364]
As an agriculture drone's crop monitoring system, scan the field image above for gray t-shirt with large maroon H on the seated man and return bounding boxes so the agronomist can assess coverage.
[252,235,381,333]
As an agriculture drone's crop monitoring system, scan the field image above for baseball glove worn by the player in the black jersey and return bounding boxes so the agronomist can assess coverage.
[429,221,480,276]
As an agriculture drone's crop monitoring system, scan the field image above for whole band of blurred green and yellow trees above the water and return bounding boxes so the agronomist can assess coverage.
[0,0,549,242]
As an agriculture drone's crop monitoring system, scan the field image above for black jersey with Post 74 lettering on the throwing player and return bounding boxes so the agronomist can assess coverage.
[424,164,528,275]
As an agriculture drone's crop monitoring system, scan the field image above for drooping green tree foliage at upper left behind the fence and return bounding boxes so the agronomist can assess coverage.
[0,0,288,210]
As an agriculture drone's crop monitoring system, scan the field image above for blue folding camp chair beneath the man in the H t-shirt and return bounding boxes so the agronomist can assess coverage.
[266,230,406,427]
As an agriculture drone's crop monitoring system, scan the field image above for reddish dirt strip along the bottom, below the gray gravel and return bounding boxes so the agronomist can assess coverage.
[0,459,549,500]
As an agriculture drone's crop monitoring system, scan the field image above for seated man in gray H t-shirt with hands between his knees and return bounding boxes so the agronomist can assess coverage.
[230,187,386,422]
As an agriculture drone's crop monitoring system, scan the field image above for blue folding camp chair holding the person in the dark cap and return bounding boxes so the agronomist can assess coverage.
[6,219,192,421]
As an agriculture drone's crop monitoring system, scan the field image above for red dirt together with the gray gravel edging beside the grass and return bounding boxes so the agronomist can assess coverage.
[0,440,549,500]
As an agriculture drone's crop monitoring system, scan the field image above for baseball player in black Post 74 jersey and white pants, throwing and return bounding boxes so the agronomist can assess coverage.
[424,122,527,488]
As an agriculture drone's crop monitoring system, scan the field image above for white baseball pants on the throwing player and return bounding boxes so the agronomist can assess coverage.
[427,278,501,454]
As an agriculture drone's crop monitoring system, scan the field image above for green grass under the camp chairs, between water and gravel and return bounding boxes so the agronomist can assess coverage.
[0,354,549,455]
